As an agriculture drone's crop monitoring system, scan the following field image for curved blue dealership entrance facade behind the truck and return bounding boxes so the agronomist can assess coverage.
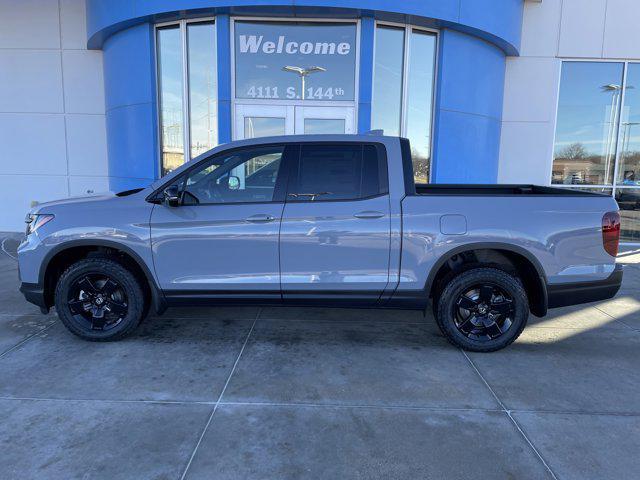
[87,0,523,191]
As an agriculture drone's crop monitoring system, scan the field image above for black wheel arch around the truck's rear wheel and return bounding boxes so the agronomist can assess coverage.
[425,242,548,317]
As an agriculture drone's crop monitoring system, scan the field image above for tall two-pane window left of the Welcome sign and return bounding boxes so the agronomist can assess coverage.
[156,21,218,175]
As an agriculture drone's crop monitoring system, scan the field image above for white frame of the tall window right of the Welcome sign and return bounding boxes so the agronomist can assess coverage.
[371,20,440,183]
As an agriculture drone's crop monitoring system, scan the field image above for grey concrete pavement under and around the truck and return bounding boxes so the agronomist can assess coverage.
[0,234,640,480]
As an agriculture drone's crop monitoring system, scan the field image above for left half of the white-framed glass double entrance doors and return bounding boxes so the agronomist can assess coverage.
[234,105,295,140]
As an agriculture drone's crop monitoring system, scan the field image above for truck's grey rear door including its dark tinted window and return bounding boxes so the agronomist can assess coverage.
[280,143,390,304]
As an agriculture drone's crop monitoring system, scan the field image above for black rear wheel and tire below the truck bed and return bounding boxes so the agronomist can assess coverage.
[436,267,529,352]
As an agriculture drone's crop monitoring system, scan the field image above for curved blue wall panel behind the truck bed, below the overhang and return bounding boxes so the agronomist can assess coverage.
[432,30,505,183]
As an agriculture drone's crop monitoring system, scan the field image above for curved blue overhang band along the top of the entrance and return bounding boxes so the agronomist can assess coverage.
[87,0,523,54]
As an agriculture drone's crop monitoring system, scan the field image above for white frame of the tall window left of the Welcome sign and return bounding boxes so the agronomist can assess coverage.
[153,16,219,174]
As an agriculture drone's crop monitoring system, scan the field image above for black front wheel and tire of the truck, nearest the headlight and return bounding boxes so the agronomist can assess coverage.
[55,258,145,342]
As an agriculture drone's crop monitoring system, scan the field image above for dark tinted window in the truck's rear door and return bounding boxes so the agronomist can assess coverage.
[289,144,388,201]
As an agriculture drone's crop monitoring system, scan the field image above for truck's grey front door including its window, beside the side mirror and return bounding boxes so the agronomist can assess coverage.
[151,145,289,300]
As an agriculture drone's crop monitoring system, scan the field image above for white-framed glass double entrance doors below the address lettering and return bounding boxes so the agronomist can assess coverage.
[234,104,355,140]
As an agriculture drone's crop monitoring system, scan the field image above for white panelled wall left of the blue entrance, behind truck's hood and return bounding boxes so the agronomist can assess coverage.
[0,0,109,231]
